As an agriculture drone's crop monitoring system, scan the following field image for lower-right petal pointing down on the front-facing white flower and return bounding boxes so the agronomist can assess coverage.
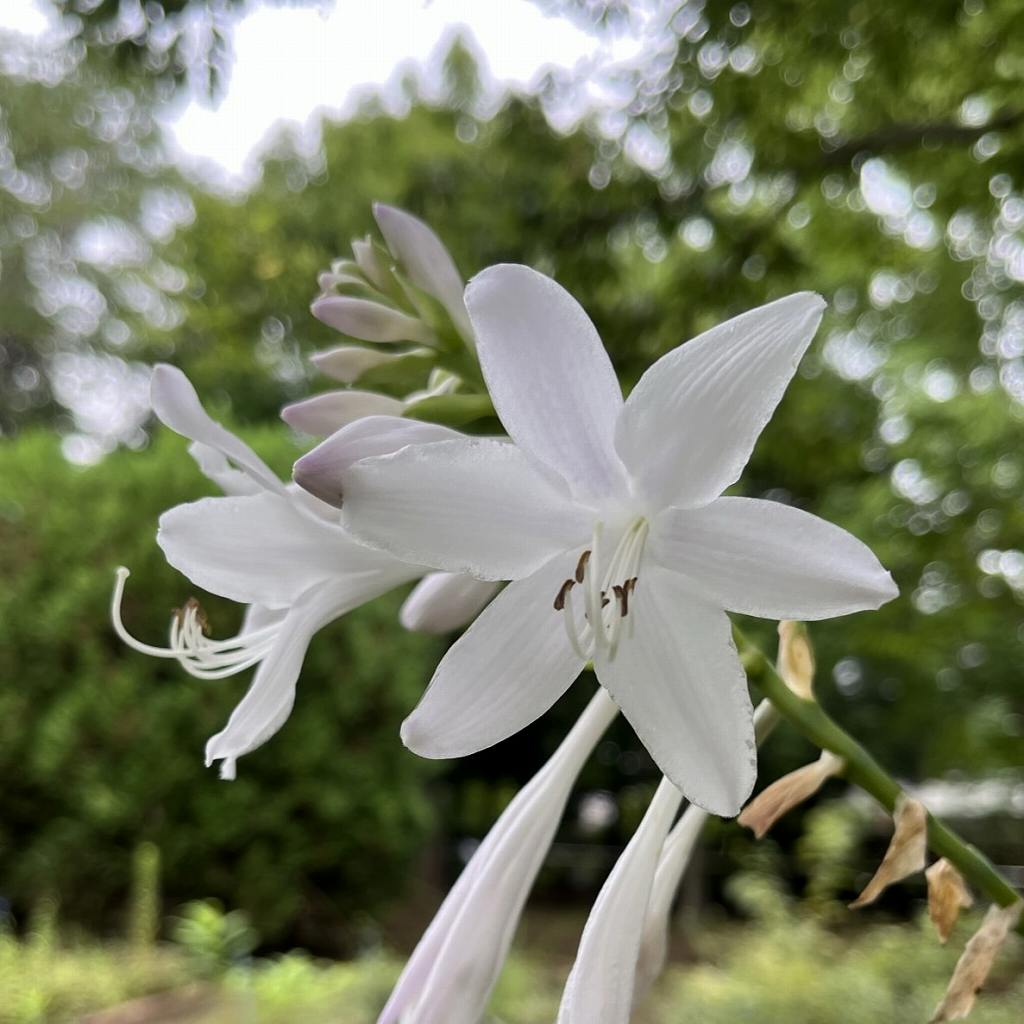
[595,559,757,817]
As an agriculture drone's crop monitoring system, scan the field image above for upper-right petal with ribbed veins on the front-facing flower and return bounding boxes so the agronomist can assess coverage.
[615,292,825,509]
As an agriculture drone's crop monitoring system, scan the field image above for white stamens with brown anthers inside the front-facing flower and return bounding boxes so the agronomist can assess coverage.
[554,516,649,662]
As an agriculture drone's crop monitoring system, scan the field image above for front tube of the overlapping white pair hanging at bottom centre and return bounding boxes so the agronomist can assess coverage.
[558,778,683,1024]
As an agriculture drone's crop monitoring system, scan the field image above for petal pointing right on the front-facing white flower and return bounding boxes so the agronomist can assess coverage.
[649,498,897,620]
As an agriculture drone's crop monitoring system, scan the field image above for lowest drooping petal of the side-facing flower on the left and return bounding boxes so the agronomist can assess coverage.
[206,581,366,778]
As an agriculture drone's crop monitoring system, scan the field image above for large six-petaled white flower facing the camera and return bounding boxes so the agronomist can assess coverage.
[342,265,896,815]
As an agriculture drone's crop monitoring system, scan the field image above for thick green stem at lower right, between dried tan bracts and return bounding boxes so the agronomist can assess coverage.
[733,627,1020,906]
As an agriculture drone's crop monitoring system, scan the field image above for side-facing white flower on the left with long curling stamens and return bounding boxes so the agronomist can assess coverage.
[113,366,430,778]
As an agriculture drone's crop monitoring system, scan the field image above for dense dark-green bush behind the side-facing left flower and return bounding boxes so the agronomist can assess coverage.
[0,431,446,950]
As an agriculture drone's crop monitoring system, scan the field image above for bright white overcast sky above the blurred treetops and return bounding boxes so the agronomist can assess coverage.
[0,0,622,184]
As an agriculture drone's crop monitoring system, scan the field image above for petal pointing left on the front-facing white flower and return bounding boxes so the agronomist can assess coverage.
[341,437,592,594]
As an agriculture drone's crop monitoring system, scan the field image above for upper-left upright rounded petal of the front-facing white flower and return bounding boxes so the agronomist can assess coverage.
[466,263,625,498]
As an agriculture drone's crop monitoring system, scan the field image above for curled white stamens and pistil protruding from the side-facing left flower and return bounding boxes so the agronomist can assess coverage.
[111,566,281,679]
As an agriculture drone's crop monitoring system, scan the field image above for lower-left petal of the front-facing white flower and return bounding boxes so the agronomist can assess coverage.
[401,554,584,758]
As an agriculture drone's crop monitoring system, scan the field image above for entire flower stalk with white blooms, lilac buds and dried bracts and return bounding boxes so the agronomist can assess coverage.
[113,205,1020,1024]
